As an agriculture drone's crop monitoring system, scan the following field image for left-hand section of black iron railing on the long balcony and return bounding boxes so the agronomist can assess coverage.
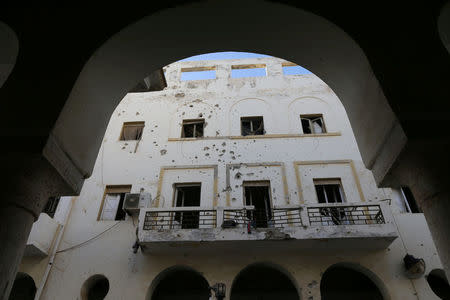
[143,207,216,230]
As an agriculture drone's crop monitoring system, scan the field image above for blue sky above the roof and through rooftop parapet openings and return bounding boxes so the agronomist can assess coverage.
[181,51,311,80]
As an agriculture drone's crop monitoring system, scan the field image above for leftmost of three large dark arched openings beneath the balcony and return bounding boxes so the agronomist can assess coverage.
[146,266,209,300]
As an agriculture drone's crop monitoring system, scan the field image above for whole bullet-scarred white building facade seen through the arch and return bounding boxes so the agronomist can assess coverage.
[16,57,445,300]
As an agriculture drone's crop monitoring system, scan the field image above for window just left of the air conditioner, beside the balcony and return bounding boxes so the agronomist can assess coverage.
[98,185,131,221]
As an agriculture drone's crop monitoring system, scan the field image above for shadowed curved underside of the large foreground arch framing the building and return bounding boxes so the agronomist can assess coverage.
[44,0,406,191]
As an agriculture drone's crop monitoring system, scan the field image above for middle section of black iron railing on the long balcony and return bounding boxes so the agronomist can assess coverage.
[223,207,302,228]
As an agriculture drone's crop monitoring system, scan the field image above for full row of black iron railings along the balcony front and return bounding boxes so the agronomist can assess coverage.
[141,203,387,230]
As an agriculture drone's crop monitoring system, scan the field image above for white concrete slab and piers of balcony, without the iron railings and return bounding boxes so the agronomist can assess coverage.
[138,202,397,253]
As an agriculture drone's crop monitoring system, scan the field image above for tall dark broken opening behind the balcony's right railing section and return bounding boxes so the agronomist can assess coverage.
[314,179,348,225]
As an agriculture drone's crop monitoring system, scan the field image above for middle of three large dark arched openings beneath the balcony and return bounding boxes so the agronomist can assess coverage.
[230,263,300,300]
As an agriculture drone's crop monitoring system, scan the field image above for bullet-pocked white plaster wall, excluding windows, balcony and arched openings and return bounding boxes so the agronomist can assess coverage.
[35,58,439,299]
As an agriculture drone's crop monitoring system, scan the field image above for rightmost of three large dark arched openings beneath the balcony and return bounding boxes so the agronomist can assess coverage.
[320,264,388,300]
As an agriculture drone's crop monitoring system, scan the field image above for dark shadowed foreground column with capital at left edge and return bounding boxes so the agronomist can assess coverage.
[0,153,73,300]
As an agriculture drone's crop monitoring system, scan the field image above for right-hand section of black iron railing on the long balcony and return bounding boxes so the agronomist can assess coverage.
[307,204,385,226]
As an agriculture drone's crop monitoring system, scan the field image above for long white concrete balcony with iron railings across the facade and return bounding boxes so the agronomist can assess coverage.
[138,202,397,253]
